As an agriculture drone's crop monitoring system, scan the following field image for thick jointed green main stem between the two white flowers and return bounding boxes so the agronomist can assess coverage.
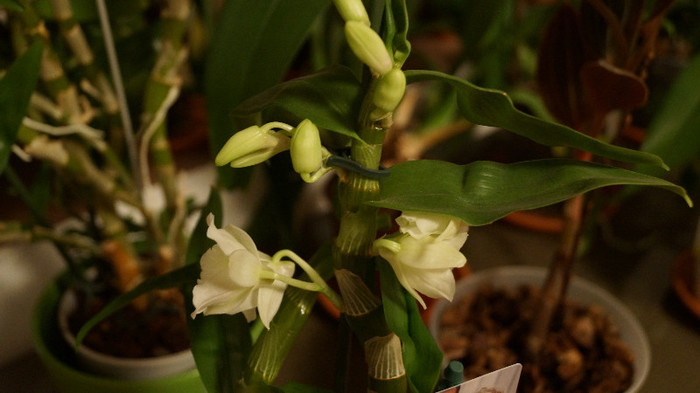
[333,72,407,393]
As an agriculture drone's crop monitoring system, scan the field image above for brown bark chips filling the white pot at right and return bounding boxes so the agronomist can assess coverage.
[438,286,634,393]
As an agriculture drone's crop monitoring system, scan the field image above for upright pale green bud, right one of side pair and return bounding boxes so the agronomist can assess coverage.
[289,119,323,174]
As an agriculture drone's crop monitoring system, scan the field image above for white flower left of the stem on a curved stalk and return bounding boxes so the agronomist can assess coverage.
[192,214,294,329]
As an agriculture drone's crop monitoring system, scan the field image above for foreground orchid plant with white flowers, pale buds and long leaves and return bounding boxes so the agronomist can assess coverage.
[74,0,691,392]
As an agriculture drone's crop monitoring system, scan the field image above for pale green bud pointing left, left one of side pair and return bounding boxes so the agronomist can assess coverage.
[214,126,289,168]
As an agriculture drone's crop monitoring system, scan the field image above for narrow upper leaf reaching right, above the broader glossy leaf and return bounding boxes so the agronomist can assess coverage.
[406,71,666,168]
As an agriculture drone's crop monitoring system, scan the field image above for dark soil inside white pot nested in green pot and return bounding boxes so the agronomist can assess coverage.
[69,290,190,358]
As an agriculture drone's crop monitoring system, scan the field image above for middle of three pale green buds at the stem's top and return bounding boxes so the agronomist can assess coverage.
[345,21,394,75]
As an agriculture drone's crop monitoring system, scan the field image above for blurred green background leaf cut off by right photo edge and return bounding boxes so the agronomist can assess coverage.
[638,52,700,175]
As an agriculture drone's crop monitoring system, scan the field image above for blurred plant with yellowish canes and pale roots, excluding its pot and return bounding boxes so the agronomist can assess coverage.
[0,0,205,298]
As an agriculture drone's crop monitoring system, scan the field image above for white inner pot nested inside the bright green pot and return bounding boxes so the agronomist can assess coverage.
[58,291,195,380]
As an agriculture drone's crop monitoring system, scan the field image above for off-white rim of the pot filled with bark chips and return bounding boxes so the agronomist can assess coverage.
[428,266,651,393]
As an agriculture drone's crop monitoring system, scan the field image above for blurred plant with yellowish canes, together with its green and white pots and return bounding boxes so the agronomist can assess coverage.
[0,0,211,392]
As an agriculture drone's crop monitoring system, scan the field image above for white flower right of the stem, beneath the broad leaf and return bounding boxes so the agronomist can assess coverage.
[374,212,469,308]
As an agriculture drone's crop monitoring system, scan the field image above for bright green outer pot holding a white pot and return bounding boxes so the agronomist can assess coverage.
[32,275,206,393]
